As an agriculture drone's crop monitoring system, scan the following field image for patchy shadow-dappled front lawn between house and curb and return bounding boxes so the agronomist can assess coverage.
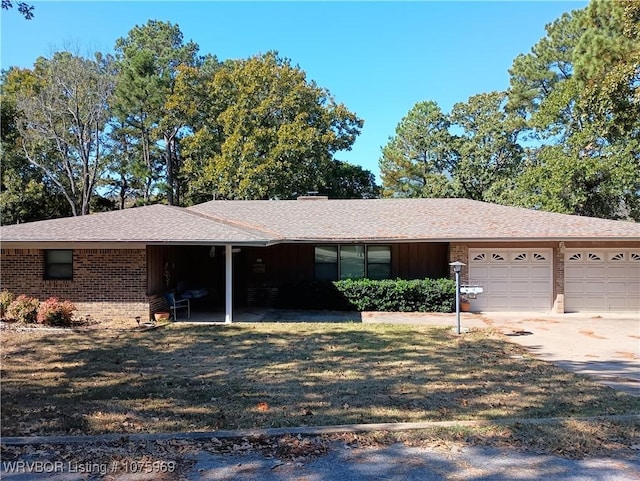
[0,323,640,444]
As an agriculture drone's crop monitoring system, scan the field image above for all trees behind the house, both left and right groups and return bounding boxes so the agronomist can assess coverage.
[0,0,640,223]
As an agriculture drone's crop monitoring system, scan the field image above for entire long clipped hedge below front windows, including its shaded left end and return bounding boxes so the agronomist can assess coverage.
[276,279,456,312]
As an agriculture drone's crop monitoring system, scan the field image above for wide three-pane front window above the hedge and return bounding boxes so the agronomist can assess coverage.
[315,245,391,281]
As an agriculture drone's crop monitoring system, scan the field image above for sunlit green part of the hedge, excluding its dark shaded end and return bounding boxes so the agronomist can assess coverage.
[333,279,456,312]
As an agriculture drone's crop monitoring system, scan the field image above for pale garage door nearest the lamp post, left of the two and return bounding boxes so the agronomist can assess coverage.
[469,249,553,311]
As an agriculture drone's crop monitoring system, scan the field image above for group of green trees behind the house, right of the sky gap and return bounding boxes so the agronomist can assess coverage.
[380,0,640,221]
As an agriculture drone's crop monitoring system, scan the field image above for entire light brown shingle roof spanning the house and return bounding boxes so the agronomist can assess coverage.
[0,199,640,245]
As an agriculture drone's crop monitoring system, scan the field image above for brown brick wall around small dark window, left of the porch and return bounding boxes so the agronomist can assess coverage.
[0,249,150,321]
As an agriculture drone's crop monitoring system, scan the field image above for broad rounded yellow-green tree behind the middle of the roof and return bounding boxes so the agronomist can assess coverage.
[184,52,362,199]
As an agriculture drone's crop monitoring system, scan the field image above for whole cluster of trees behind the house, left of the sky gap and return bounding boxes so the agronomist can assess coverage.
[0,25,378,223]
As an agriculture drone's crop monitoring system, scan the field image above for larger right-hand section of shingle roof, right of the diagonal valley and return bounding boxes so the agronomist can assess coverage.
[187,199,640,241]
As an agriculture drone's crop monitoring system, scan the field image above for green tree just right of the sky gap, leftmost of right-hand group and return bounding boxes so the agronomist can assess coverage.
[379,101,458,197]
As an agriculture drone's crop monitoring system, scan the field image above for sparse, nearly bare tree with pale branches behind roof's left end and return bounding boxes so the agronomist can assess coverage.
[10,52,113,215]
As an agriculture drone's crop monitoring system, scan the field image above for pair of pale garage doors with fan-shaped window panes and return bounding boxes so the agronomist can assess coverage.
[468,248,640,312]
